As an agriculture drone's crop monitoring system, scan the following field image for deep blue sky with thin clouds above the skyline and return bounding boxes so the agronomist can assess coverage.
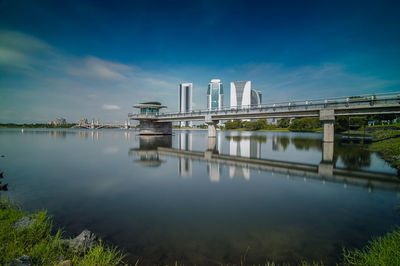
[0,0,400,123]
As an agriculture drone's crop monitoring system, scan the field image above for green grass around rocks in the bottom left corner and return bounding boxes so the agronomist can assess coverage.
[0,199,125,265]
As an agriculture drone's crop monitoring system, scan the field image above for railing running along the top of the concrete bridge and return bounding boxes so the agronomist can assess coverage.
[128,92,400,119]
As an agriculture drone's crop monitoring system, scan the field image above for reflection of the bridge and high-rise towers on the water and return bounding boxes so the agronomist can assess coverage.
[130,132,400,192]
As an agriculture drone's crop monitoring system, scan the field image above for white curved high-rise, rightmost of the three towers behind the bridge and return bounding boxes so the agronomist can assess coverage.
[231,81,262,108]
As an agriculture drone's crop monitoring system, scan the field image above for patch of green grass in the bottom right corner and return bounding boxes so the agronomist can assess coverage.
[343,230,400,266]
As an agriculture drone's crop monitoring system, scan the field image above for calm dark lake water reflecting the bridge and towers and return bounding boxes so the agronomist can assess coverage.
[0,129,400,265]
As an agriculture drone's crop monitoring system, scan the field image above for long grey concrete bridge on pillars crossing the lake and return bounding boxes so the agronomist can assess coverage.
[128,92,400,142]
